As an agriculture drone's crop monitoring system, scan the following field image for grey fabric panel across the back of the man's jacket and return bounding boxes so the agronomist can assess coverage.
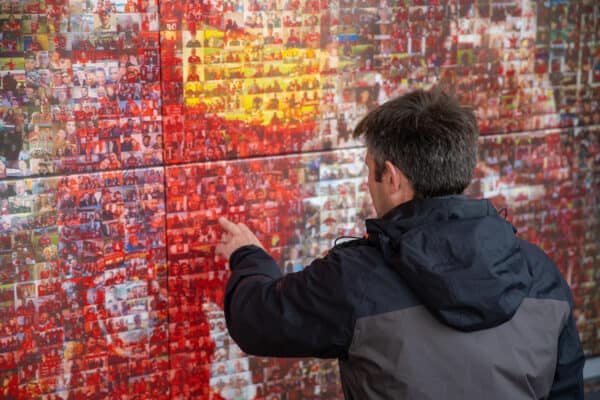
[340,298,570,400]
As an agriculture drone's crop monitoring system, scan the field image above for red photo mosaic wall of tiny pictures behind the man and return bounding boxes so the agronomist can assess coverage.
[0,0,600,400]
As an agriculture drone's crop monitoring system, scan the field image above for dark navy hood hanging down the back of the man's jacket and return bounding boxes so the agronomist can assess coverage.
[367,196,532,331]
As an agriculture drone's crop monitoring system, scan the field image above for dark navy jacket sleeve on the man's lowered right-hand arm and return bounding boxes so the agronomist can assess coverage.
[548,306,585,400]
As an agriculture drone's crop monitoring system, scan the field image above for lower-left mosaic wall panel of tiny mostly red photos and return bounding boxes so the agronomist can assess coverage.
[0,169,169,399]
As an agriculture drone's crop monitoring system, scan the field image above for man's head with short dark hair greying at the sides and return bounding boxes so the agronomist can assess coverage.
[354,88,479,216]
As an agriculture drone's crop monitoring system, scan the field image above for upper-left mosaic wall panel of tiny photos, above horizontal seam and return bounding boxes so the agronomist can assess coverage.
[0,0,163,178]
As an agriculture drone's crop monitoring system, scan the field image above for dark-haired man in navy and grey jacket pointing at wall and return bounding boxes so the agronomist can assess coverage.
[217,89,584,400]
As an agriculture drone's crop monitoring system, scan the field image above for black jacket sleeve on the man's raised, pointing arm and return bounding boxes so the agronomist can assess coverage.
[225,246,354,358]
